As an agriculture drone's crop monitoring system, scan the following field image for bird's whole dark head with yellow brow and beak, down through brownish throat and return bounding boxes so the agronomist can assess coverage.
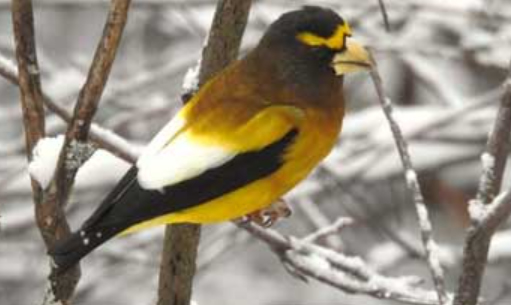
[248,6,368,101]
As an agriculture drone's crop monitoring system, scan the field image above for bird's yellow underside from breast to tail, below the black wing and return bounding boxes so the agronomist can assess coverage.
[122,108,342,234]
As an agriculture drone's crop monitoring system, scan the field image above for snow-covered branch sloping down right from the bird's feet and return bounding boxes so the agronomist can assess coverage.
[237,222,444,305]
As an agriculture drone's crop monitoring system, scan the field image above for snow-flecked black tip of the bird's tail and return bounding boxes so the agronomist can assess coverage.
[49,227,120,273]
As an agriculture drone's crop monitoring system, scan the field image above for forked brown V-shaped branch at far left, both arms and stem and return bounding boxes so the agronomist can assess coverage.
[13,0,130,304]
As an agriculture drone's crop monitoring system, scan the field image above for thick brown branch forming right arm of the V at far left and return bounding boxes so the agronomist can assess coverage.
[27,0,130,304]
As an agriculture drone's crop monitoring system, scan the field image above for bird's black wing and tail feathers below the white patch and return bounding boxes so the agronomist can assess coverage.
[50,129,298,271]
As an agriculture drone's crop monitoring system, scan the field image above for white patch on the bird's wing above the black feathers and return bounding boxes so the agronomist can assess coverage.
[137,116,236,190]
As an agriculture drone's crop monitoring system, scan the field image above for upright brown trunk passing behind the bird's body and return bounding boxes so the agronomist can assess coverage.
[158,0,252,305]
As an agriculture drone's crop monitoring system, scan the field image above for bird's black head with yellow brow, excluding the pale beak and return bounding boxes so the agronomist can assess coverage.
[250,6,362,87]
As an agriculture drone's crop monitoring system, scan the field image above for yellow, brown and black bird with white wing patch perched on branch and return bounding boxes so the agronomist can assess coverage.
[50,6,372,272]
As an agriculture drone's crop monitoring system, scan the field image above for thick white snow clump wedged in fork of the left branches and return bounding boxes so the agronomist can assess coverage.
[28,135,64,188]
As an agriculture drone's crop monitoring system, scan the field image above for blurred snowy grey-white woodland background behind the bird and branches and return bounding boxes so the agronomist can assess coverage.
[0,0,511,305]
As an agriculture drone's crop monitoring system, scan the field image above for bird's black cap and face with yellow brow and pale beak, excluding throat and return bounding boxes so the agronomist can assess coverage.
[258,6,371,81]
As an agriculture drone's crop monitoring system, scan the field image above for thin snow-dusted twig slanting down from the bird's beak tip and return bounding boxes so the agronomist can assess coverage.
[371,54,448,305]
